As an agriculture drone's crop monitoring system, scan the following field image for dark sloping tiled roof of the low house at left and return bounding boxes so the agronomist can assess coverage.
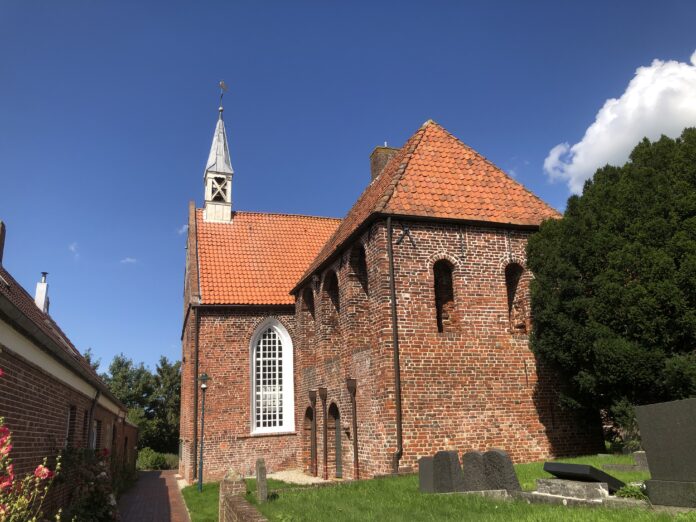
[0,266,117,398]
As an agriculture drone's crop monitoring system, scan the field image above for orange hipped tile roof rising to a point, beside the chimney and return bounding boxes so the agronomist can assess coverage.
[299,120,560,283]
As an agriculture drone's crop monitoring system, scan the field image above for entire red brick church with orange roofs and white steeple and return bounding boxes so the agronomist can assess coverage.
[180,102,602,482]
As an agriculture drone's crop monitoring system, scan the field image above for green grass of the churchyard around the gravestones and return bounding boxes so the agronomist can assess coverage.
[183,455,696,522]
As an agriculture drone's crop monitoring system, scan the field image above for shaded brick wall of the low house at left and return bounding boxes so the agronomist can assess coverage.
[0,346,137,512]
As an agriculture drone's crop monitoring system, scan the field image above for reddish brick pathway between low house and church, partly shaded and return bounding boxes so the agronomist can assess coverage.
[118,471,191,522]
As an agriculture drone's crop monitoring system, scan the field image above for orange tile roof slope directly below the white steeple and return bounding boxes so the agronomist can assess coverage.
[196,209,341,305]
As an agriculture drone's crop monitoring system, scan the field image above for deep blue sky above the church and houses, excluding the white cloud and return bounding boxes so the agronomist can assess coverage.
[0,0,696,367]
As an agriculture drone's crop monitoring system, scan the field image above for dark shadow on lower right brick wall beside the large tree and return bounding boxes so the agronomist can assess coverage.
[533,354,605,457]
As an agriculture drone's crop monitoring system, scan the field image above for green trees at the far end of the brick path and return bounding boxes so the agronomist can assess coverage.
[102,354,181,453]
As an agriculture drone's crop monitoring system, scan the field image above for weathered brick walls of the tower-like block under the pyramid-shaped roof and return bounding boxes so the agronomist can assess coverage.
[296,217,601,477]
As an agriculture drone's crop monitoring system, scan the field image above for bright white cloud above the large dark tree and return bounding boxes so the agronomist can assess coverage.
[544,52,696,194]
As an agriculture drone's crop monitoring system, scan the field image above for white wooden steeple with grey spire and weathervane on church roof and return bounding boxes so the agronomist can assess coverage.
[203,82,234,219]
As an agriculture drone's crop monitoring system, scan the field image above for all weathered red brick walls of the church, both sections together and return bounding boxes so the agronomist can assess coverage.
[182,213,601,480]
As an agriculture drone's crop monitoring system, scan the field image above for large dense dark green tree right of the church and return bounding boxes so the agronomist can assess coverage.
[528,129,696,432]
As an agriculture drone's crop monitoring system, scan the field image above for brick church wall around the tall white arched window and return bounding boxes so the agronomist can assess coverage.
[180,307,297,481]
